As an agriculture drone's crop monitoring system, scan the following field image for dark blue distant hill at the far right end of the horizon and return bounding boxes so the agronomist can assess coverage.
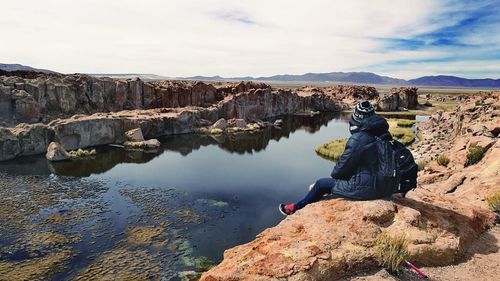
[408,75,500,88]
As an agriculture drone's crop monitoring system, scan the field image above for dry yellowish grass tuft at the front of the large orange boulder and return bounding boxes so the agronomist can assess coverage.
[375,231,409,272]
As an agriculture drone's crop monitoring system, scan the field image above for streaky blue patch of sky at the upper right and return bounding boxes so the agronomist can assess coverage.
[368,0,500,78]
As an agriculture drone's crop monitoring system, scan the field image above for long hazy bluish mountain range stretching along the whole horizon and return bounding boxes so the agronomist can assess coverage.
[0,63,500,88]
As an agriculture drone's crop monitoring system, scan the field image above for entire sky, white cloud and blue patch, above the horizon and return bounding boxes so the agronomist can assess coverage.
[0,0,500,79]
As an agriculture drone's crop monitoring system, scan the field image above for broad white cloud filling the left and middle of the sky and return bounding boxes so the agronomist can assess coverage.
[0,0,496,76]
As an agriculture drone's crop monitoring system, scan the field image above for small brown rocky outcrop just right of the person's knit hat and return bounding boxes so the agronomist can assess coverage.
[377,87,418,111]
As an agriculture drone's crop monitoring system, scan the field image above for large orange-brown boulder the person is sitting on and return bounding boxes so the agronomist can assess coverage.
[201,190,495,281]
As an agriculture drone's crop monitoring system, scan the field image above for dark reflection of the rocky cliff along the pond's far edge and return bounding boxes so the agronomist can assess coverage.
[0,113,349,177]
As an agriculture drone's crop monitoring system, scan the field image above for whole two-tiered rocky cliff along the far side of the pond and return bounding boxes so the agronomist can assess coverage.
[0,71,376,161]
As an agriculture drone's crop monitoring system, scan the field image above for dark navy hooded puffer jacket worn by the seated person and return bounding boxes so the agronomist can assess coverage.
[331,115,390,200]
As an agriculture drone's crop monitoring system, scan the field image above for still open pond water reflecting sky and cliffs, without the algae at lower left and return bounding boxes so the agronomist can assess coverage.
[0,114,424,279]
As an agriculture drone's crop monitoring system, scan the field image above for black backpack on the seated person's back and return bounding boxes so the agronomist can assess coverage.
[375,135,418,197]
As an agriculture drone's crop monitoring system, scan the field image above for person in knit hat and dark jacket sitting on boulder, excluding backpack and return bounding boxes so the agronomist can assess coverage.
[279,101,391,215]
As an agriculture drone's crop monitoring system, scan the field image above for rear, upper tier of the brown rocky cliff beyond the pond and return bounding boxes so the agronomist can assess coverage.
[0,74,352,126]
